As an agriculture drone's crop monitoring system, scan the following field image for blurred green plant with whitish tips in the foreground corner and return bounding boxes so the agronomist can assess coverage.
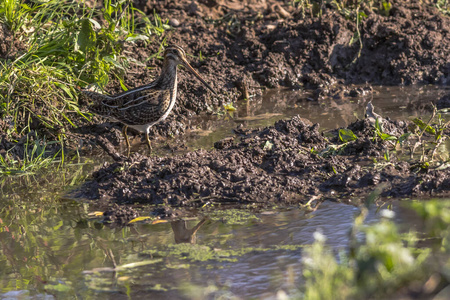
[301,200,450,299]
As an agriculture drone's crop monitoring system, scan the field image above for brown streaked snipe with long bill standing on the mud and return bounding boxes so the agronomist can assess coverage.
[83,46,217,156]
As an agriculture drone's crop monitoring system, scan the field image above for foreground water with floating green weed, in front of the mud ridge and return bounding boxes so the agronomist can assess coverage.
[0,193,404,299]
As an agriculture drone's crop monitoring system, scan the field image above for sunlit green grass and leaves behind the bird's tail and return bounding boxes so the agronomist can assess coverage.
[0,0,168,139]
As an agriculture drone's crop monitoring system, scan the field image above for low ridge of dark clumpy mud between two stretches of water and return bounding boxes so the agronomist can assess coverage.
[77,116,450,216]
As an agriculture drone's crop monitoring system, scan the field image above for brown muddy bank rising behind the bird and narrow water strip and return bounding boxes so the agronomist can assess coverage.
[75,0,450,144]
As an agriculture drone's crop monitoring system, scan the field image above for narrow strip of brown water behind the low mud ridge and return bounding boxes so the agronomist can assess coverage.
[153,86,450,155]
